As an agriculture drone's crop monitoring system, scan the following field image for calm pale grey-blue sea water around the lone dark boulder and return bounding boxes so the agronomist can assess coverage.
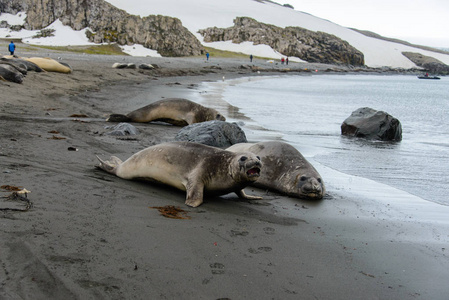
[199,75,449,205]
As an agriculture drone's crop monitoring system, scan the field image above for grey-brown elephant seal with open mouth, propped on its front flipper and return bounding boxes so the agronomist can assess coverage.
[97,142,262,207]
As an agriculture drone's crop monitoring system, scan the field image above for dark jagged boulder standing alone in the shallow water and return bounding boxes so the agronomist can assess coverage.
[341,107,402,141]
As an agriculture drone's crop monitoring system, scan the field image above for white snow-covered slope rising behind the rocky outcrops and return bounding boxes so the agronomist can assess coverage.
[0,0,449,68]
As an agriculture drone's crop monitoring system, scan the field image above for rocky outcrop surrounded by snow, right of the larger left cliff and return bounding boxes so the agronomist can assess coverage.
[199,17,365,66]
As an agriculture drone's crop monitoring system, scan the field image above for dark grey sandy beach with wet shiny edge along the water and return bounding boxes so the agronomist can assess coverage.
[0,40,449,299]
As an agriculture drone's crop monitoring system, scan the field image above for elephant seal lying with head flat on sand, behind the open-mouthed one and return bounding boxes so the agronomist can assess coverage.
[226,141,326,200]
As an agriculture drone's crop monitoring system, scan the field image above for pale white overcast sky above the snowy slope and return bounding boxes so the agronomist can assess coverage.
[288,0,449,48]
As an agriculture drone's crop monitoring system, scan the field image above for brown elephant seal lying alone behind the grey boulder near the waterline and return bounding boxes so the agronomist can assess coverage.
[106,98,226,126]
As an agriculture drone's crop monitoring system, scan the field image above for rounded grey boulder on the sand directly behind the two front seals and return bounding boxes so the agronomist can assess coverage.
[175,121,248,148]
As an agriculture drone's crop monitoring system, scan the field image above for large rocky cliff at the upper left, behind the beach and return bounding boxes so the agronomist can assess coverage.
[0,0,204,56]
